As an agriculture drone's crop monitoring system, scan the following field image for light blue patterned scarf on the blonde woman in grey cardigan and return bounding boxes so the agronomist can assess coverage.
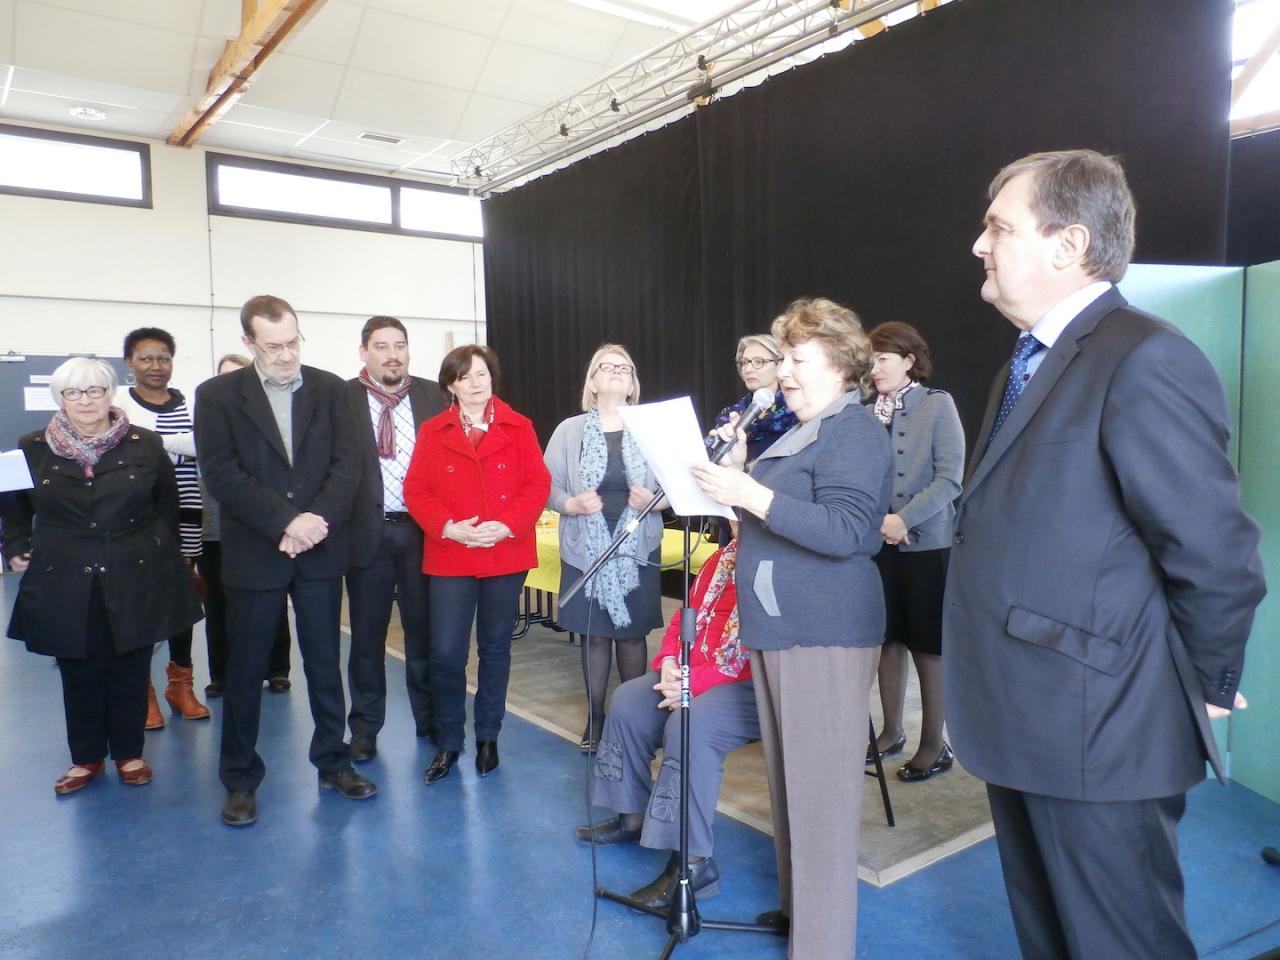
[579,407,648,627]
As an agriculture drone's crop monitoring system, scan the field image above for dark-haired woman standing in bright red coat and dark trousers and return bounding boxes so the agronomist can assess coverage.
[404,343,550,783]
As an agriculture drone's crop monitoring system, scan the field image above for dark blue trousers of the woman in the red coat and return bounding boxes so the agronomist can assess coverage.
[430,571,525,750]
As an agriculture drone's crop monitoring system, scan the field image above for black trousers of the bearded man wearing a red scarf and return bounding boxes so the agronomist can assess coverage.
[347,518,434,736]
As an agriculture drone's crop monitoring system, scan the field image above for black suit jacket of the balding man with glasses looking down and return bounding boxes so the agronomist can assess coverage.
[196,365,360,590]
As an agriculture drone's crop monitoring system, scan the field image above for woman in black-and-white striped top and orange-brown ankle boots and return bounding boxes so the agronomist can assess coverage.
[119,326,209,730]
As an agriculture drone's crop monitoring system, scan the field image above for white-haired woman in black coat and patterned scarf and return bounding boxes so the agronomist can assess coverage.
[4,357,200,794]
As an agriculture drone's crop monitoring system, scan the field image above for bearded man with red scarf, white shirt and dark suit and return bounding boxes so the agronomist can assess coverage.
[347,316,444,763]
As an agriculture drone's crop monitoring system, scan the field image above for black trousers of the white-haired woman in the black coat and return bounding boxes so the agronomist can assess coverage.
[58,577,154,764]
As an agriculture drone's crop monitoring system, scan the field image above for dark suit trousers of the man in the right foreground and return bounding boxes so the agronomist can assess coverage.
[987,785,1196,960]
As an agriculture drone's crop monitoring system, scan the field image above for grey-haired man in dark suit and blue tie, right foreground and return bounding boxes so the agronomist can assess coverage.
[942,151,1265,960]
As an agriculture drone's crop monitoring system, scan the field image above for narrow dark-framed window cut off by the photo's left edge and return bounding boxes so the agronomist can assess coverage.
[0,124,151,207]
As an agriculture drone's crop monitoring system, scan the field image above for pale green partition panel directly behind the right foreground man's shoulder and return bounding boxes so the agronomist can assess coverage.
[1120,264,1244,764]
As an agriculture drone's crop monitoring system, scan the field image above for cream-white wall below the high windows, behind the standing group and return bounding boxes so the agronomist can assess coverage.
[0,124,484,396]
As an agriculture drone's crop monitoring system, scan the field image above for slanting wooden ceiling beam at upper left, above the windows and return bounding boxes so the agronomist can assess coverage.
[169,0,325,147]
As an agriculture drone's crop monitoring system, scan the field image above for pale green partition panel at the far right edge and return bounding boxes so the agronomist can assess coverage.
[1231,261,1280,803]
